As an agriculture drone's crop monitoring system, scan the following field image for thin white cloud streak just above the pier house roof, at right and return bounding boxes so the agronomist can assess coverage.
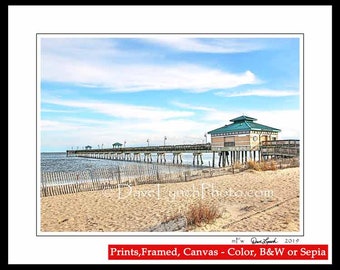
[216,89,300,97]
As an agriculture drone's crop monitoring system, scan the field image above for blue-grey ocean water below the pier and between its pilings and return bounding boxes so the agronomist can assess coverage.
[40,152,212,173]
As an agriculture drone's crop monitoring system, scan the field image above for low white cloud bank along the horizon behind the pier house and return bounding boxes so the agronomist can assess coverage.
[41,103,302,150]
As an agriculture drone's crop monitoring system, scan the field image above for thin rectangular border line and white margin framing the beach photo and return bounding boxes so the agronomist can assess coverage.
[35,32,305,238]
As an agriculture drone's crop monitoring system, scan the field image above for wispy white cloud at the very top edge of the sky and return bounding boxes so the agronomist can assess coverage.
[147,37,264,53]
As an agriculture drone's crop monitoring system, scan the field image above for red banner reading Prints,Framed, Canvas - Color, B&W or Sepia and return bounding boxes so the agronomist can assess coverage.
[108,244,328,260]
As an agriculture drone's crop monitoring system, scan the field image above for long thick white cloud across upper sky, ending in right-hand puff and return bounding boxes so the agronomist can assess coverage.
[42,55,258,92]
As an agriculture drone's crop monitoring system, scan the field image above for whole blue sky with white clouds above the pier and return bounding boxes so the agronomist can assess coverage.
[38,35,302,152]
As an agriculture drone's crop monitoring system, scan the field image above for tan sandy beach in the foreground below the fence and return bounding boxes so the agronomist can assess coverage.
[40,167,300,233]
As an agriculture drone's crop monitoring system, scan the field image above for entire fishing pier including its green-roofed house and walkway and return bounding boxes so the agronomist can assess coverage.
[67,115,300,167]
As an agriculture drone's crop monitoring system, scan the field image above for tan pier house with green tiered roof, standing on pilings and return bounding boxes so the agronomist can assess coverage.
[208,115,281,166]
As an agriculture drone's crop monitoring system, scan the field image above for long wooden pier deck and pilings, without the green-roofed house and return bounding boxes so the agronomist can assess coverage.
[66,140,300,167]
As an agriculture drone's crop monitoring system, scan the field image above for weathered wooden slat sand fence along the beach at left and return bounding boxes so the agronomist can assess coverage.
[40,164,209,197]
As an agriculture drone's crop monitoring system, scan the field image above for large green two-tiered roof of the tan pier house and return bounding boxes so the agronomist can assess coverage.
[208,115,281,134]
